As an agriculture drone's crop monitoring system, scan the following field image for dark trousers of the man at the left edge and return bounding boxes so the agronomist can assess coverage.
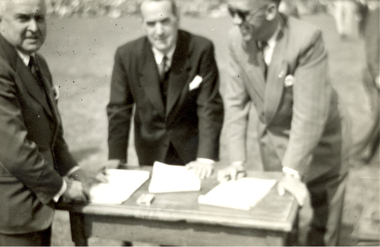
[0,227,51,246]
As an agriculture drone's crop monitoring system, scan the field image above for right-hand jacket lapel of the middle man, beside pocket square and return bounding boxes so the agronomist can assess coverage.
[166,31,191,116]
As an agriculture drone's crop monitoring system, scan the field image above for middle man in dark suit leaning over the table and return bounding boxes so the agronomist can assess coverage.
[107,0,223,178]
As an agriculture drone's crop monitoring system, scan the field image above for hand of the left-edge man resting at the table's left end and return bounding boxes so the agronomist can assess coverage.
[62,178,90,202]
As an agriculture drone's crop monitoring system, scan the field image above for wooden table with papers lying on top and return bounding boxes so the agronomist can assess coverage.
[57,171,298,246]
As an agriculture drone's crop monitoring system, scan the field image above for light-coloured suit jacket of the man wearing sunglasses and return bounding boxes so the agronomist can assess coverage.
[225,15,348,180]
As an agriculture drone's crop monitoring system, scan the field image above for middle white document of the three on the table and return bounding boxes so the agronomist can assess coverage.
[149,161,201,193]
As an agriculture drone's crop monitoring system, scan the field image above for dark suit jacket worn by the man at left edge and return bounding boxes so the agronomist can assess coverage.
[0,35,77,233]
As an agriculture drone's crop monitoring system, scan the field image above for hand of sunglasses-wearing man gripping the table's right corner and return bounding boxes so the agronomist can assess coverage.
[277,175,308,206]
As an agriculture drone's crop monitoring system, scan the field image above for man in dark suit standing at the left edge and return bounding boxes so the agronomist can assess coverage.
[0,0,94,243]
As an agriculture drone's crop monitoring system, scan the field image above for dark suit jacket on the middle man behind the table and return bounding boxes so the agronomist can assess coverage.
[107,30,223,165]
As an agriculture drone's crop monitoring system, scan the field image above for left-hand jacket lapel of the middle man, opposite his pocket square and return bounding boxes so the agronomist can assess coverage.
[140,41,165,115]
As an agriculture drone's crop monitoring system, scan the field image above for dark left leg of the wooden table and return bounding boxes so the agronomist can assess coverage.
[70,212,88,246]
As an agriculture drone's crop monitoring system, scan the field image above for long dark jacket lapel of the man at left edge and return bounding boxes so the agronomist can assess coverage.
[17,59,55,119]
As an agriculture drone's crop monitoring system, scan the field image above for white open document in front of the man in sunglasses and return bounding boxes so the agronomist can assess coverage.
[198,178,276,210]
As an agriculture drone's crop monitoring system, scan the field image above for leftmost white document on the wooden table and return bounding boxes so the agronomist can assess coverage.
[90,169,150,204]
